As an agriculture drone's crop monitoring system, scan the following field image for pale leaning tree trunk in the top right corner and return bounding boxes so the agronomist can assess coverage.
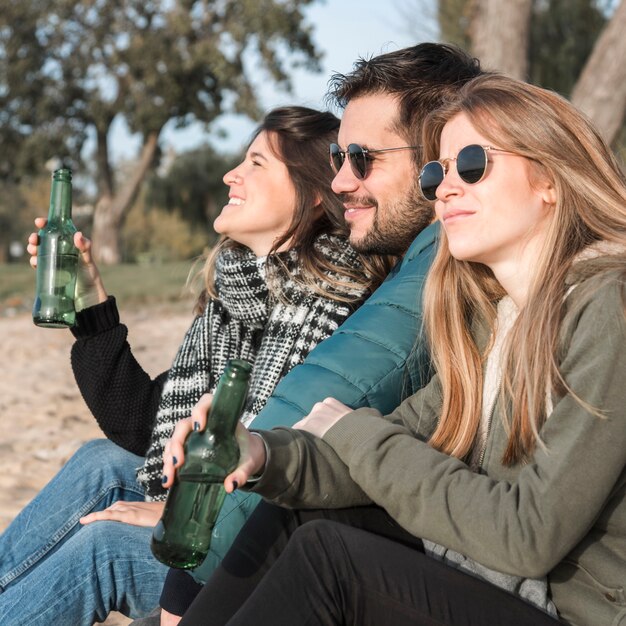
[572,0,626,143]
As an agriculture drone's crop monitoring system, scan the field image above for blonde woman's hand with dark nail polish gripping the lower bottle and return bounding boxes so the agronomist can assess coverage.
[163,393,266,493]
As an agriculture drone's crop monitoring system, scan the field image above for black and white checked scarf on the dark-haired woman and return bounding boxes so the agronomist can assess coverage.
[137,235,367,500]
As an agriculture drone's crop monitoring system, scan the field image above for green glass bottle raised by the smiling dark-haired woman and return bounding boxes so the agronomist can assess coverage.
[33,167,78,328]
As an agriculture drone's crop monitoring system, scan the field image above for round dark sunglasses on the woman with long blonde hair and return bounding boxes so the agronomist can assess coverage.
[419,144,515,202]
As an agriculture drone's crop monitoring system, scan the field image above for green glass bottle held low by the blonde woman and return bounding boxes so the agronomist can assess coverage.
[152,359,252,569]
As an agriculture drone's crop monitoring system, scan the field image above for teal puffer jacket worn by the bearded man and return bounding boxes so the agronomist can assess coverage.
[192,223,439,582]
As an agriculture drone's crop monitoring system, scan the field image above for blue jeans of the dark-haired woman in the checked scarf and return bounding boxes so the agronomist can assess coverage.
[0,439,167,626]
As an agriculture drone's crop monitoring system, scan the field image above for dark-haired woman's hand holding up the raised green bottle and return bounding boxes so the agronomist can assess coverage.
[26,217,107,311]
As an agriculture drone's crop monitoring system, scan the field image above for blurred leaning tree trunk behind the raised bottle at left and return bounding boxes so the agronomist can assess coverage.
[92,131,159,265]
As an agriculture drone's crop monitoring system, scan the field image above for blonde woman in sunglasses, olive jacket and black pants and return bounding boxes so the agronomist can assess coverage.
[172,75,626,626]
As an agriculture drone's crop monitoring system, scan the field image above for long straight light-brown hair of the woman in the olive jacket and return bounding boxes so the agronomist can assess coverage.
[416,75,626,465]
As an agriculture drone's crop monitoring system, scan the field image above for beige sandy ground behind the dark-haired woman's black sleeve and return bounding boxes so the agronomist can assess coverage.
[0,309,191,626]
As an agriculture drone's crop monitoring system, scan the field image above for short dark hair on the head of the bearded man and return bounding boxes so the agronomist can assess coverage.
[327,43,484,149]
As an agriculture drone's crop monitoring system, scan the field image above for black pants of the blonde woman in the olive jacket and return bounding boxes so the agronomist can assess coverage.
[180,503,559,626]
